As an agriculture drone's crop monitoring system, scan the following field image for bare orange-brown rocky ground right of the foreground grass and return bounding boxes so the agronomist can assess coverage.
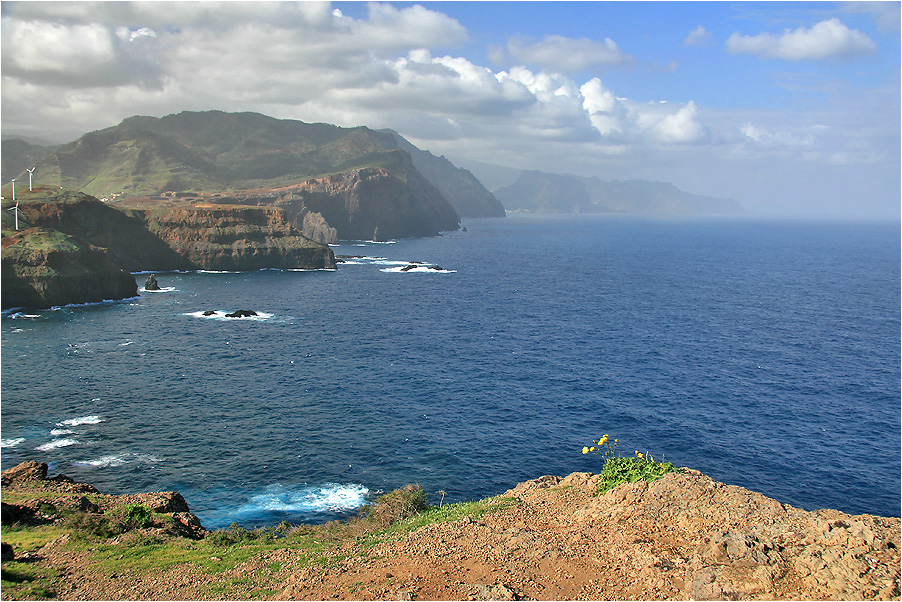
[278,471,900,600]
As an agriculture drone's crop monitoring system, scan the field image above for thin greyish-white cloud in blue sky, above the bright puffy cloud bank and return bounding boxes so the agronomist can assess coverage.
[507,35,629,73]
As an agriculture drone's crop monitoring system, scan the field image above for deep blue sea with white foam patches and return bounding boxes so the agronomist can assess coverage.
[2,215,900,527]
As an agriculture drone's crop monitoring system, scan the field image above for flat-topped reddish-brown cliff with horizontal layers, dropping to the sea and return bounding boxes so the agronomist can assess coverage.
[143,204,335,271]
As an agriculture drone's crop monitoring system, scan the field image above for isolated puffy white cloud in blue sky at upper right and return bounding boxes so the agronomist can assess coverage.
[726,18,877,61]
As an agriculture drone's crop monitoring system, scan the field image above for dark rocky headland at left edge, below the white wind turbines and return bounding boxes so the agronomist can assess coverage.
[0,228,138,309]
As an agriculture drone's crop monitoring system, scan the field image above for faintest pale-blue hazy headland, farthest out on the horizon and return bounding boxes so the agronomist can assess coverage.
[495,170,744,215]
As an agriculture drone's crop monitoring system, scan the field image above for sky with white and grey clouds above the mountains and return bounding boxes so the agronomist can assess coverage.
[0,1,900,218]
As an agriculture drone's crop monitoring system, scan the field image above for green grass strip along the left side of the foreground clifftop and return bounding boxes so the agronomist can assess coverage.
[3,486,517,599]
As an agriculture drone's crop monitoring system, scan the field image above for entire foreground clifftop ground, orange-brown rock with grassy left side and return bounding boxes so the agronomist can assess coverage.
[3,460,900,600]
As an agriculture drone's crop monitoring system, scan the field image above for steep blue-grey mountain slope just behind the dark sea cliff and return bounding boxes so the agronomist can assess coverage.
[381,130,504,217]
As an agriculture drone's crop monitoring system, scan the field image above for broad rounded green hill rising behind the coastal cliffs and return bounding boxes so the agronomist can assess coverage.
[13,111,414,197]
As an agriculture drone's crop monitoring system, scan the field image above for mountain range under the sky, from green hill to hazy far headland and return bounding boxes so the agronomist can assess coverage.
[2,111,742,221]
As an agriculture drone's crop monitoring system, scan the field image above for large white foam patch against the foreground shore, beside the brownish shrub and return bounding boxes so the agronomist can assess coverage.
[238,483,369,514]
